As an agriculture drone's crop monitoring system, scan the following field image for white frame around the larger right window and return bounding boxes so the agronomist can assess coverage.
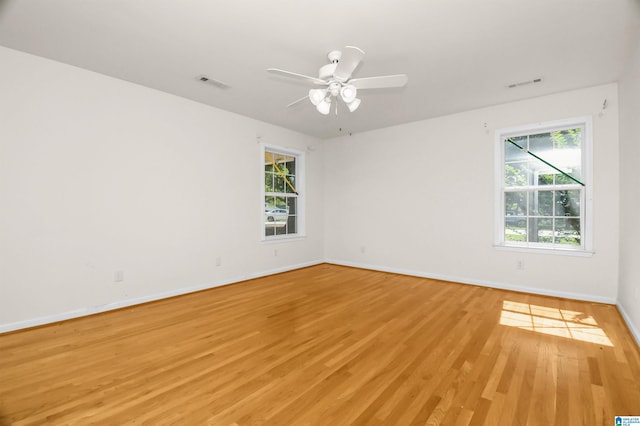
[494,116,593,256]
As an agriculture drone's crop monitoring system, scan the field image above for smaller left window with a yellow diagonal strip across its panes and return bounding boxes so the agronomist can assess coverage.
[262,147,303,239]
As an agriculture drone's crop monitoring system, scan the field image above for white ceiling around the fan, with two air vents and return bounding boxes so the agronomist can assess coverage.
[0,0,640,138]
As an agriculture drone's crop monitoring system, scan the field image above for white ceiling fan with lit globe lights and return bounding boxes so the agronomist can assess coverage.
[267,46,408,115]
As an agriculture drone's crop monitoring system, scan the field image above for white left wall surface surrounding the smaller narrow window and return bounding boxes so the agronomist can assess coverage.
[0,47,324,331]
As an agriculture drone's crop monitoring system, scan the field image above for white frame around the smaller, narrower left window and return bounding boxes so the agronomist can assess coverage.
[259,143,306,242]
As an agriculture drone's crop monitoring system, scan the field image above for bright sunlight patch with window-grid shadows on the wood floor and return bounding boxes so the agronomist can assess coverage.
[500,300,613,346]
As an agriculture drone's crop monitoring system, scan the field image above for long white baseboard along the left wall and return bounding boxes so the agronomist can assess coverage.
[0,259,324,333]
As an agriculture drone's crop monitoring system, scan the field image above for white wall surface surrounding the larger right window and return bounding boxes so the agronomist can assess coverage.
[324,84,619,302]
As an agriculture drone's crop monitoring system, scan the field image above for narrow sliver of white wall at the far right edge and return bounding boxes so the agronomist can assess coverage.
[618,32,640,343]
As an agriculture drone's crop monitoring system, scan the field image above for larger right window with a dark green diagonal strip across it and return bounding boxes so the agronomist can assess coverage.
[496,119,591,250]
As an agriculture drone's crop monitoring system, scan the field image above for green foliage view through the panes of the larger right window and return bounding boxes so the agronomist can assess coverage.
[503,126,584,248]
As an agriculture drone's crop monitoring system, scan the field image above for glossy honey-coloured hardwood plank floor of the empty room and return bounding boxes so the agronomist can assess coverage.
[0,264,640,425]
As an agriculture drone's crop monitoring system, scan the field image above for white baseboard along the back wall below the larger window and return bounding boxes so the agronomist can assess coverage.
[326,259,616,305]
